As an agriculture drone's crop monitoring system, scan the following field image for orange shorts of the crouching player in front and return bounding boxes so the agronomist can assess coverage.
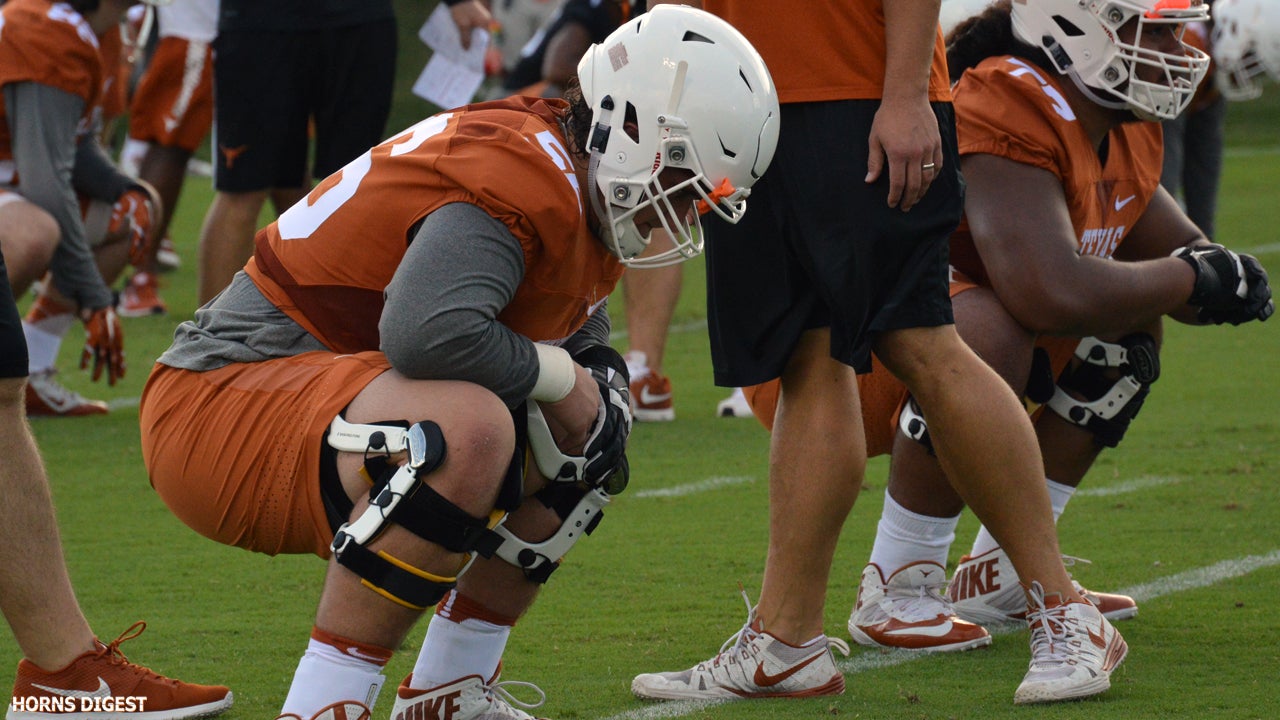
[138,352,390,557]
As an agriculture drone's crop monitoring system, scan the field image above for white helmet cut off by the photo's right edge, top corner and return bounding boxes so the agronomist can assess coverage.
[1213,0,1280,100]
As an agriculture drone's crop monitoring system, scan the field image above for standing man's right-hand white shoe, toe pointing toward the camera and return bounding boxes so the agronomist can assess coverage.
[1014,583,1129,705]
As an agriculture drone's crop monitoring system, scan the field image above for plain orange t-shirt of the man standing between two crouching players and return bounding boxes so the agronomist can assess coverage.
[703,0,951,102]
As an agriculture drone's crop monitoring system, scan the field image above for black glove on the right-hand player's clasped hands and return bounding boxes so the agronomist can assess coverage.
[1174,245,1275,325]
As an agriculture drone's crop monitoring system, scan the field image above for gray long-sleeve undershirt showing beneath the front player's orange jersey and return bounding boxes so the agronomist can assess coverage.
[160,202,609,406]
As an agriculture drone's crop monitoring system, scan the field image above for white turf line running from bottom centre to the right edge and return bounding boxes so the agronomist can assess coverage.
[604,550,1280,720]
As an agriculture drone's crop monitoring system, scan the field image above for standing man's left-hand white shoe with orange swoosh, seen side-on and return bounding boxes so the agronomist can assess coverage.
[631,592,849,700]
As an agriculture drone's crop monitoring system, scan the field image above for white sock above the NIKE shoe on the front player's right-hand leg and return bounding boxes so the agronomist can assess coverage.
[410,612,511,691]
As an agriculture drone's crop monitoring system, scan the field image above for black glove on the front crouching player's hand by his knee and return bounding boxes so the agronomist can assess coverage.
[573,345,631,495]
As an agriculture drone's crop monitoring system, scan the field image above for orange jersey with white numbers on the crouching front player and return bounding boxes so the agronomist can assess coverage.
[244,97,622,352]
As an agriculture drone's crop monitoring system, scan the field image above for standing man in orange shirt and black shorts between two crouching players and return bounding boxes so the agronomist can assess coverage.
[631,0,1071,681]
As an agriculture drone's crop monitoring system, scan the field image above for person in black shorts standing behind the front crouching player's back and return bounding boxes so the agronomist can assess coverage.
[192,0,397,304]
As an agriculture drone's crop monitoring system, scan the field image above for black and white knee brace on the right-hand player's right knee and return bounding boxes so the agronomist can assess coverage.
[1048,333,1160,447]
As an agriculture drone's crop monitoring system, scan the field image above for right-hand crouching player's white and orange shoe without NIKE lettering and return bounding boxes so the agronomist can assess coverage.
[849,561,991,652]
